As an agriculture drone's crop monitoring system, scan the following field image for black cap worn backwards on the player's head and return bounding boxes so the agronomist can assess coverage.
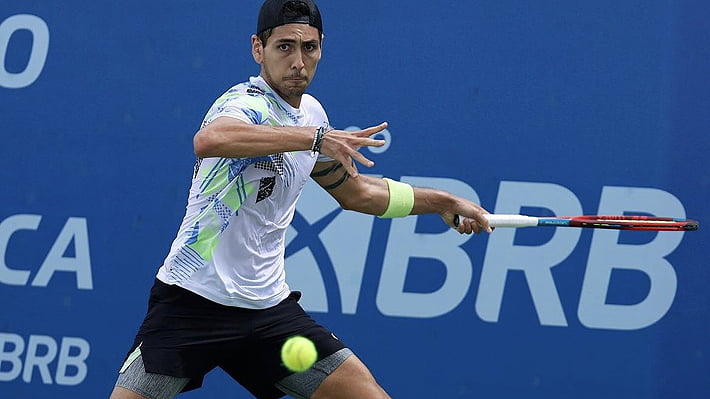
[256,0,323,35]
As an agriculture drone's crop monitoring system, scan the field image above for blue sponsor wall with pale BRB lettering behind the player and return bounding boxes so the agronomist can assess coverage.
[0,0,710,399]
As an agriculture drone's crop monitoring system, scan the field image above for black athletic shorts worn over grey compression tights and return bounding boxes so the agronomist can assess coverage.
[123,279,345,398]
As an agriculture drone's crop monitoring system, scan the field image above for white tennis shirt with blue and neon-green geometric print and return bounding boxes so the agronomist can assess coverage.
[158,78,328,308]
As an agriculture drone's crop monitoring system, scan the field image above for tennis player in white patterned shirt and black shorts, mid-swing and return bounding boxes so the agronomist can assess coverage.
[111,0,491,399]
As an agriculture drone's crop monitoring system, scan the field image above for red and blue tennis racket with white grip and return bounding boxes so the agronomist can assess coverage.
[454,214,698,231]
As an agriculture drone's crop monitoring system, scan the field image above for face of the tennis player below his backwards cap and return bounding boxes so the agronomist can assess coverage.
[252,24,321,107]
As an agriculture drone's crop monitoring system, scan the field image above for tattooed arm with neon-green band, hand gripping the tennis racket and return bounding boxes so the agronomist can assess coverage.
[311,161,492,234]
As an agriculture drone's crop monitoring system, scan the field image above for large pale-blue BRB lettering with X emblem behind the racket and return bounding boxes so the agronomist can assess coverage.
[286,176,685,330]
